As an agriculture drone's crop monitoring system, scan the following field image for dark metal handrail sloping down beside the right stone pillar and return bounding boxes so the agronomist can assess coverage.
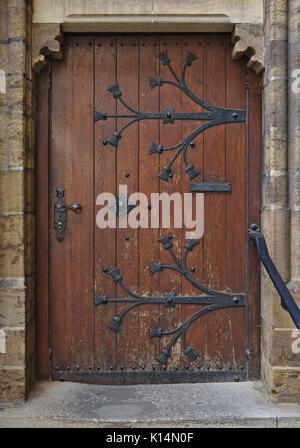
[248,224,300,329]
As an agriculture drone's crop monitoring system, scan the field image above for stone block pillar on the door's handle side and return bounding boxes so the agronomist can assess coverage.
[0,0,34,400]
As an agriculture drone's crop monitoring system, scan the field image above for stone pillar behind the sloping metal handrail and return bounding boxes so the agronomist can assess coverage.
[262,0,300,401]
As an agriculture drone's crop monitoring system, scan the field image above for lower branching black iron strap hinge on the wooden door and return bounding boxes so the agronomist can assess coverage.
[94,234,245,365]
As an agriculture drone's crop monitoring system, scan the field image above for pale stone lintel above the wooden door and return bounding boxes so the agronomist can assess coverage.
[33,0,263,27]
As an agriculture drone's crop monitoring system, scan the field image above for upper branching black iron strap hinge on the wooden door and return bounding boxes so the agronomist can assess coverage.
[94,50,246,182]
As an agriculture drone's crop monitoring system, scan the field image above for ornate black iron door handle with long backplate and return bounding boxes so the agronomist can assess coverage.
[54,188,82,243]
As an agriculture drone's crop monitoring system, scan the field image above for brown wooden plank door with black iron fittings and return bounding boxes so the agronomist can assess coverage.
[37,34,261,384]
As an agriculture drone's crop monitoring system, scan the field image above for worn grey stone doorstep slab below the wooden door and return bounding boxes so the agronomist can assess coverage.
[0,381,300,428]
